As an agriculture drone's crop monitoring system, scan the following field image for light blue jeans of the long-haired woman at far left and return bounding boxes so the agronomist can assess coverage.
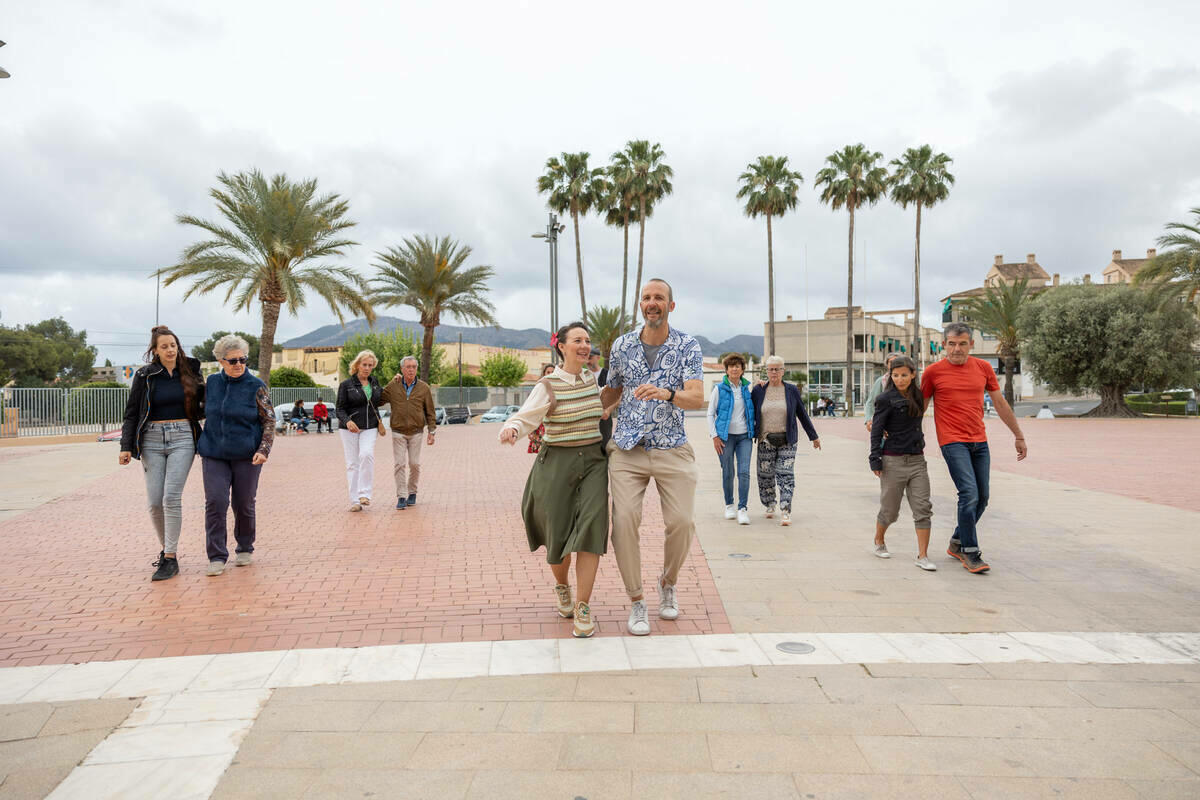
[142,422,196,553]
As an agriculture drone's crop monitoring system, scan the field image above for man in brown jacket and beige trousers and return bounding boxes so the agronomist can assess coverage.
[382,355,438,510]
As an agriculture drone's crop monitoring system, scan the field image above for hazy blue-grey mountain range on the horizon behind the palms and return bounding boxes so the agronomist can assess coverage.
[280,317,762,357]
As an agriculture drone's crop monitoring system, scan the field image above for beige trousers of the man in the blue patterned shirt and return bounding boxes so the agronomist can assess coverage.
[608,441,700,597]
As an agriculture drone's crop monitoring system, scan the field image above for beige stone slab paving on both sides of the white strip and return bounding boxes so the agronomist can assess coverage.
[0,421,1200,800]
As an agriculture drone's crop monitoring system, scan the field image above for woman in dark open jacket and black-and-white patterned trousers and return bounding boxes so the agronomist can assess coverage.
[750,355,821,525]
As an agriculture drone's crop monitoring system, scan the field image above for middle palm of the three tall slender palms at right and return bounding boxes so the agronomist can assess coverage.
[814,143,888,416]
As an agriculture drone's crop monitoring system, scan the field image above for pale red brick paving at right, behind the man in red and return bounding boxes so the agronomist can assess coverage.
[818,419,1200,511]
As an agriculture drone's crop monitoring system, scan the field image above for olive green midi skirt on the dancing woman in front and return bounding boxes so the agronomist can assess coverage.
[521,443,608,564]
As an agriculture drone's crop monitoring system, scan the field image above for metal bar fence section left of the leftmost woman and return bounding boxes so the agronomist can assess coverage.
[0,389,130,439]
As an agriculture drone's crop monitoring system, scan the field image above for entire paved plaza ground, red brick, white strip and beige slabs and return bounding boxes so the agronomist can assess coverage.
[0,420,1200,800]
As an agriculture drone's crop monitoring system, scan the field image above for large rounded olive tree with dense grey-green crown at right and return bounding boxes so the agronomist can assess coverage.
[1020,284,1200,416]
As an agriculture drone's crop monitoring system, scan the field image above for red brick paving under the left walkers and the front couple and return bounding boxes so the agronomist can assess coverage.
[0,425,731,666]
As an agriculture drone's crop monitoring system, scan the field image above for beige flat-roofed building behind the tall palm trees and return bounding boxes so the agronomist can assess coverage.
[763,306,942,405]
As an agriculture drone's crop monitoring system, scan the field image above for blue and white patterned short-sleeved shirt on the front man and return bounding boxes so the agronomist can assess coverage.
[608,327,704,450]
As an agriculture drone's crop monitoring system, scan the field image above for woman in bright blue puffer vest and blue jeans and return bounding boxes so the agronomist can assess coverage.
[708,353,754,525]
